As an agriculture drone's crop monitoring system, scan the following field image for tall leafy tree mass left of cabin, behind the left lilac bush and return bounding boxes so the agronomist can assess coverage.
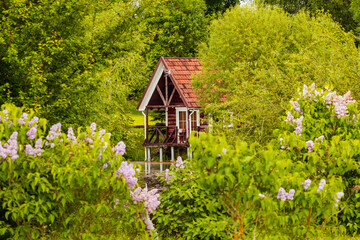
[0,0,147,142]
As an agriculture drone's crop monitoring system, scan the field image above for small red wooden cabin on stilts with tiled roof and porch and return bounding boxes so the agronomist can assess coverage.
[137,57,206,160]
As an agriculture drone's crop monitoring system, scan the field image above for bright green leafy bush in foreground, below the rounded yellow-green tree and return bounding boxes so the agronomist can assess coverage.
[191,134,341,239]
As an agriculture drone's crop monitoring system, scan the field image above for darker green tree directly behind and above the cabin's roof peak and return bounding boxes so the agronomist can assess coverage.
[139,0,208,69]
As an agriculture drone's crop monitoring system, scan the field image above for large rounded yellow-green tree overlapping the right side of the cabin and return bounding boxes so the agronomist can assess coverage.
[193,5,360,142]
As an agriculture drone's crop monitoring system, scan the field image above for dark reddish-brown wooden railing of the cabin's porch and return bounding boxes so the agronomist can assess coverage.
[143,126,188,146]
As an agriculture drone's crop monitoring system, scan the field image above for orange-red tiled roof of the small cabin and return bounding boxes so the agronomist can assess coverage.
[160,57,202,108]
